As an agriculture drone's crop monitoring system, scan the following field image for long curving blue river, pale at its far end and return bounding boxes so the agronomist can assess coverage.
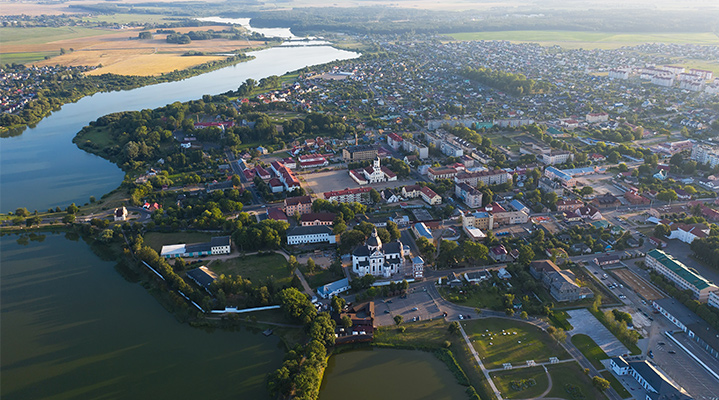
[0,46,359,213]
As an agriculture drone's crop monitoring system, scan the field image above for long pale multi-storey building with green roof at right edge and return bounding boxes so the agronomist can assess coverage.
[644,249,719,303]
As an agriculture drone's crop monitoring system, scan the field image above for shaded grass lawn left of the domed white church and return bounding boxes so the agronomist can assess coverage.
[208,253,292,285]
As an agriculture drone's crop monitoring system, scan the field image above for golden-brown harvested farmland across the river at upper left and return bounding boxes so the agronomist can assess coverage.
[0,26,264,76]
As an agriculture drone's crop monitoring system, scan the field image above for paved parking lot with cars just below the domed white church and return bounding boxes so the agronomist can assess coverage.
[375,288,442,326]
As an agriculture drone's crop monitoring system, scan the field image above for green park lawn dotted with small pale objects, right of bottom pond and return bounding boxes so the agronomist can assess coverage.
[462,318,569,369]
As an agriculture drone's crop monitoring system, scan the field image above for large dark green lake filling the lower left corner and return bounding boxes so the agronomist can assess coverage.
[0,235,284,400]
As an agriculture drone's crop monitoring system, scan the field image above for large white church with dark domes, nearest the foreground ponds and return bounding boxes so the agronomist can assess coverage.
[352,228,404,278]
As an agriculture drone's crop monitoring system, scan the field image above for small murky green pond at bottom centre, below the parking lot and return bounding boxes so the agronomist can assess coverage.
[320,348,467,400]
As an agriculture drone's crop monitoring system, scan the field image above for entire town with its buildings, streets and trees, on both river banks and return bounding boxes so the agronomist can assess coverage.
[0,6,719,400]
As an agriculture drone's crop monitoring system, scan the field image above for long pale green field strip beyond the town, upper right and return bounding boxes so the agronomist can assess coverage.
[451,31,719,49]
